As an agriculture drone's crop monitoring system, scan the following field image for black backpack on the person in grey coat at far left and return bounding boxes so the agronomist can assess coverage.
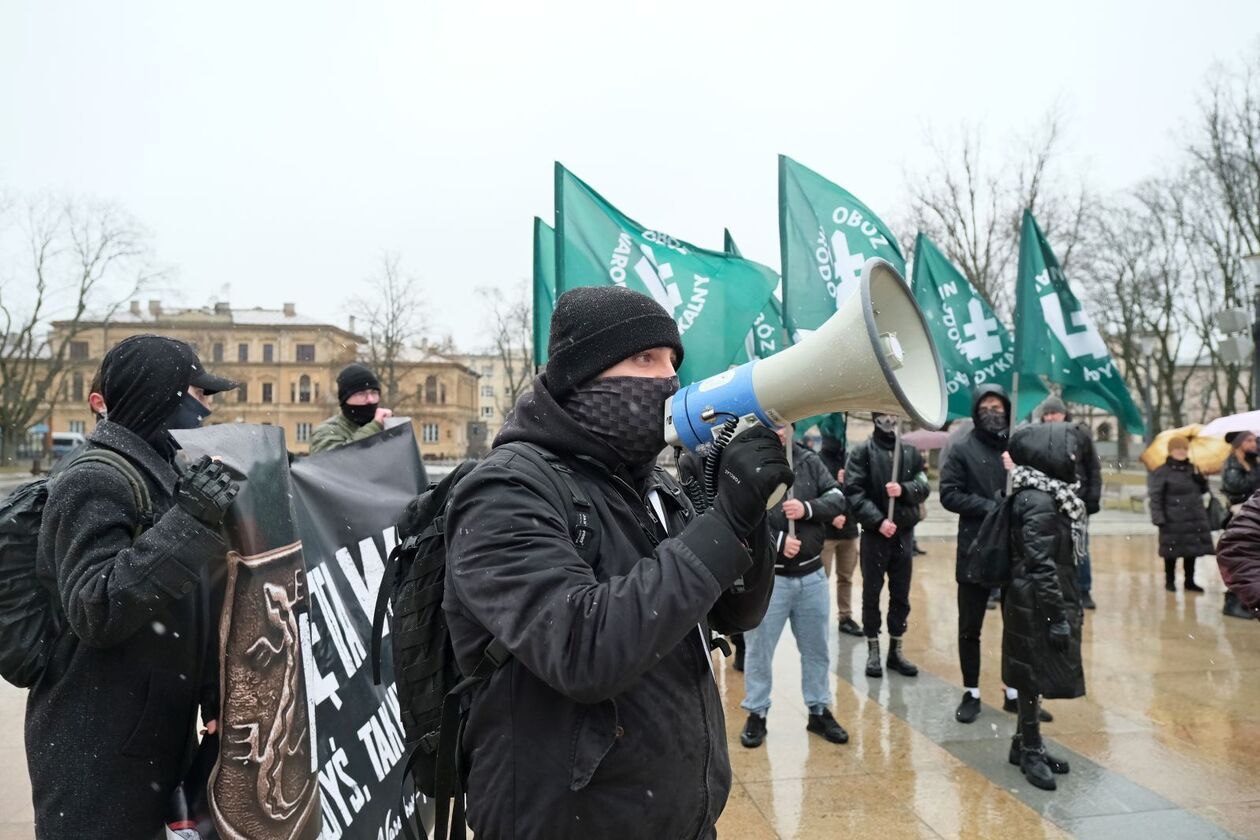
[0,450,152,689]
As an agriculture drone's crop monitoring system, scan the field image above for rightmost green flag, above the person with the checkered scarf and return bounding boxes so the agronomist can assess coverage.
[1014,210,1147,434]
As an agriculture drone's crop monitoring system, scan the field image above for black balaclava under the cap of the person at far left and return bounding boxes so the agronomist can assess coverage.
[101,335,202,460]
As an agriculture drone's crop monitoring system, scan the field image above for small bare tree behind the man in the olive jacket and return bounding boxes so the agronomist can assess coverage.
[349,253,426,412]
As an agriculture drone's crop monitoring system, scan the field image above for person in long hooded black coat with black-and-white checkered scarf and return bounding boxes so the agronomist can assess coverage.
[1002,423,1086,791]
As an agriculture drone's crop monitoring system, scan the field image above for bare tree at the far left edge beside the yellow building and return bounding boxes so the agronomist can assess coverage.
[0,196,163,465]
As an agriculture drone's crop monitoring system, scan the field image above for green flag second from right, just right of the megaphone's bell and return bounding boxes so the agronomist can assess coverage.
[911,233,1046,419]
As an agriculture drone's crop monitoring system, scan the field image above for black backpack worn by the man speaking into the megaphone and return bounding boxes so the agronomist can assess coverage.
[372,442,600,840]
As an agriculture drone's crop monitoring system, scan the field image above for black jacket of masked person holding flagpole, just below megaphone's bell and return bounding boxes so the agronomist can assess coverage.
[844,432,932,531]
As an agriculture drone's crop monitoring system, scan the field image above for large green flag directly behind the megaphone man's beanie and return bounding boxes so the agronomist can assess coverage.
[556,164,777,384]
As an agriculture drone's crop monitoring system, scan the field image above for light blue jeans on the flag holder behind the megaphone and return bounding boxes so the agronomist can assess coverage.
[740,569,832,717]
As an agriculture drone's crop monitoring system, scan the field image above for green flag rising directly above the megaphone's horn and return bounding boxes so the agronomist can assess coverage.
[779,155,906,340]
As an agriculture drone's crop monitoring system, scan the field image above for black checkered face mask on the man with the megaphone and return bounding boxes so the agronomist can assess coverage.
[564,377,678,467]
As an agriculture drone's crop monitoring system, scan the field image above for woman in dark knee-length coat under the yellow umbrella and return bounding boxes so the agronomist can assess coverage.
[1147,436,1216,592]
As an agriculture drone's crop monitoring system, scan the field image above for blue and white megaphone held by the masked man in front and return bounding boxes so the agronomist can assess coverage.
[665,259,946,452]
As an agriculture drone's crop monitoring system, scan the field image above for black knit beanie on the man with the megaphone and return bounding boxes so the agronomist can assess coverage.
[547,286,683,400]
